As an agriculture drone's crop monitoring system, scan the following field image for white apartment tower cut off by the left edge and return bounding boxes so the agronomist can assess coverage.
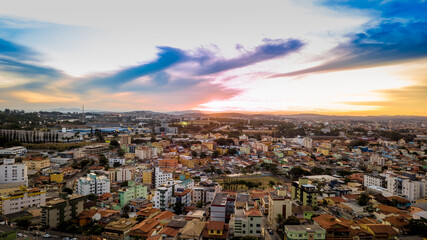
[0,159,28,187]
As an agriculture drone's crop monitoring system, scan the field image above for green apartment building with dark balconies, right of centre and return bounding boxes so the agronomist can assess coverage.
[292,177,317,208]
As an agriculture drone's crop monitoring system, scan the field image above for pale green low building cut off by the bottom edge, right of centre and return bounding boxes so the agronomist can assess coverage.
[285,225,326,240]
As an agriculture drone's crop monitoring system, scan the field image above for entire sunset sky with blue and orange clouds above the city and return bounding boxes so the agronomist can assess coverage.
[0,0,427,116]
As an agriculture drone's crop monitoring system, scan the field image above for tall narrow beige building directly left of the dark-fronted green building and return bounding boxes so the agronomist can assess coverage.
[268,191,292,227]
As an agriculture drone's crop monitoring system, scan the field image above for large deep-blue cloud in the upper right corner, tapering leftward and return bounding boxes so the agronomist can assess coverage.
[271,1,427,78]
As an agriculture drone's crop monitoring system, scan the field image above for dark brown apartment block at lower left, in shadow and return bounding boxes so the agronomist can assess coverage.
[41,195,85,228]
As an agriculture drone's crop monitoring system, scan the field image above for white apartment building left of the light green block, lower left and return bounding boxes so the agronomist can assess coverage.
[76,173,110,195]
